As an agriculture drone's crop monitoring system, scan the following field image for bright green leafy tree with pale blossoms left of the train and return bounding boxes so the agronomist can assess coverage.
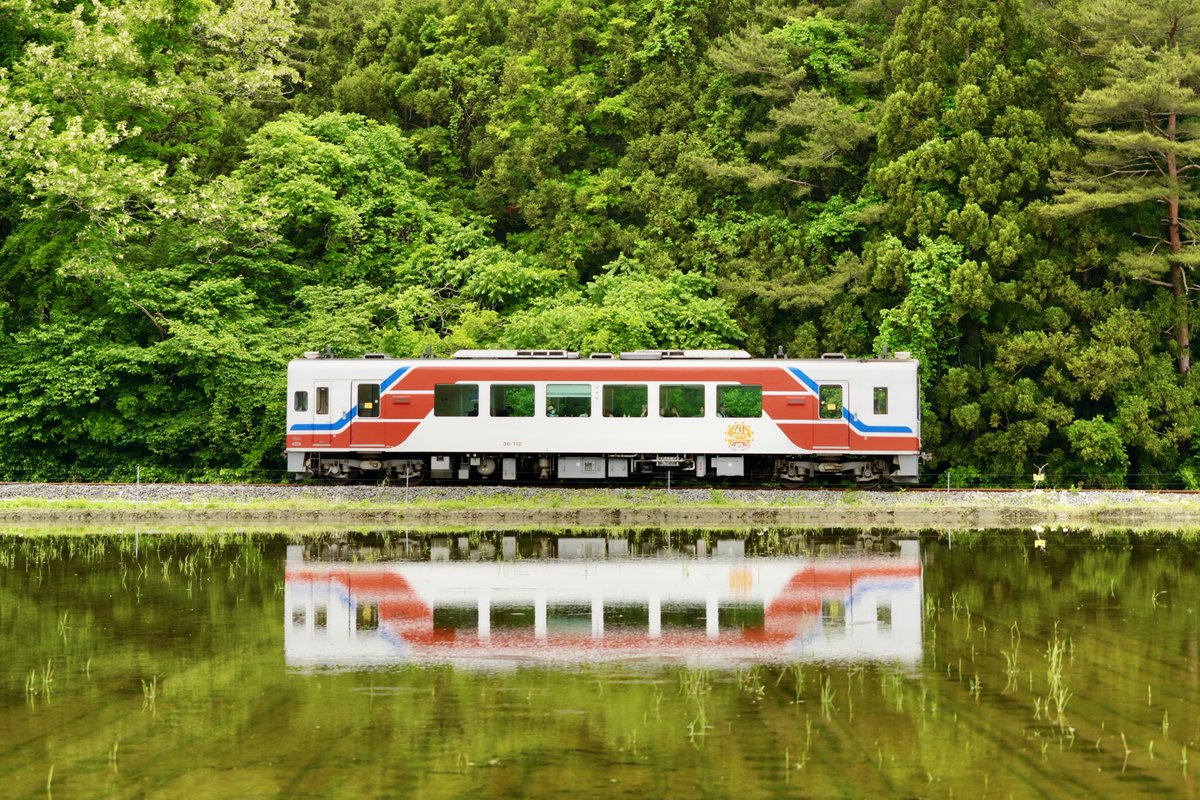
[0,0,302,477]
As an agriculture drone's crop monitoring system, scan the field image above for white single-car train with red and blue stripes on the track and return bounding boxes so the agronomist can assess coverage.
[287,350,920,483]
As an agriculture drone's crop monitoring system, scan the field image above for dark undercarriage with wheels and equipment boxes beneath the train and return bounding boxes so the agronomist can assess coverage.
[289,452,918,486]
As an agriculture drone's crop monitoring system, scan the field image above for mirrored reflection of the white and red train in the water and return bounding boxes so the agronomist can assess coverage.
[283,536,923,668]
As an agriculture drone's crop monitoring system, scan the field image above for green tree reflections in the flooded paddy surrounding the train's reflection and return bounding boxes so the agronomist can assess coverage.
[0,531,1200,798]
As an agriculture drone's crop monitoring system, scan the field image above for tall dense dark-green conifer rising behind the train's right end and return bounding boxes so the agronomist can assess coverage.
[863,0,1086,475]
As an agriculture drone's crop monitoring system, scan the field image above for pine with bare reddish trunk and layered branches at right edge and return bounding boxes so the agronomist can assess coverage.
[1046,0,1200,374]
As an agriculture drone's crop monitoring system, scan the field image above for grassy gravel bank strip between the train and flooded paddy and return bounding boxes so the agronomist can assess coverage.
[0,483,1200,533]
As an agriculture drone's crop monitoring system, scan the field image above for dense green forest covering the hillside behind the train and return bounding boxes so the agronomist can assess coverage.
[0,0,1200,487]
